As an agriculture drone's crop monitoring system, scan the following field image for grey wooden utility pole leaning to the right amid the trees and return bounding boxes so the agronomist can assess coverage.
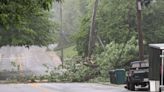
[88,0,98,59]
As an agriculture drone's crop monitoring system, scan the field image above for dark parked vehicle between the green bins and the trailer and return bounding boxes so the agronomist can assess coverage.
[126,61,149,91]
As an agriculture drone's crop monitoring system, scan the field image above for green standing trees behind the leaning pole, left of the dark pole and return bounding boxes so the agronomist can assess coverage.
[75,0,136,56]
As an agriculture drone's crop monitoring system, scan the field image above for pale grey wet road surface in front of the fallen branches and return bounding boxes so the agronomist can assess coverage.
[0,83,147,92]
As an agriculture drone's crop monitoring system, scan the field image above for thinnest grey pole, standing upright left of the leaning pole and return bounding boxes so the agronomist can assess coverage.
[60,2,64,68]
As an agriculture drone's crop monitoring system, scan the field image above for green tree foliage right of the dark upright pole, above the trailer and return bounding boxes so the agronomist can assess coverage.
[142,0,164,44]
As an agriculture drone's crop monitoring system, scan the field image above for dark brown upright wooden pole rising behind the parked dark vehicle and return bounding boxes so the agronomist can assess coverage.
[136,0,144,61]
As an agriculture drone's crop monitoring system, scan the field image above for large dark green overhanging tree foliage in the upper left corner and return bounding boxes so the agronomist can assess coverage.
[0,0,60,46]
